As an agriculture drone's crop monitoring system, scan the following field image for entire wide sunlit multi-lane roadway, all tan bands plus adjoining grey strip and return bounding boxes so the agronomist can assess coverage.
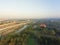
[0,22,27,35]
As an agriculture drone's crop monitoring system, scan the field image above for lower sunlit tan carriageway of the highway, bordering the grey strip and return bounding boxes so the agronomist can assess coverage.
[0,23,26,35]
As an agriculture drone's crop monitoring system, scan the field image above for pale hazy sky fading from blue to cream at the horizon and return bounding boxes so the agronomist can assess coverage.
[0,0,60,18]
